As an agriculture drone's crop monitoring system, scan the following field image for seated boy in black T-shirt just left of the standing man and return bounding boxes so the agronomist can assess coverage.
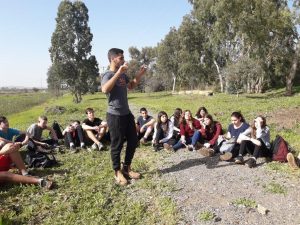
[82,108,107,151]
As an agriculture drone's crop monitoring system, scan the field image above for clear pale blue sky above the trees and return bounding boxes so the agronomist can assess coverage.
[0,0,192,88]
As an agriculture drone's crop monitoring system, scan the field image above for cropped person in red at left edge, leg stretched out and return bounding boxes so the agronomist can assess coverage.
[0,143,52,189]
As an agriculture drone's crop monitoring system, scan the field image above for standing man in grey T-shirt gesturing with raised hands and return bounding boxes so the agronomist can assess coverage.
[101,48,146,185]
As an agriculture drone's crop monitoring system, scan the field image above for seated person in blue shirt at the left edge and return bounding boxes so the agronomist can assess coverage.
[0,116,28,148]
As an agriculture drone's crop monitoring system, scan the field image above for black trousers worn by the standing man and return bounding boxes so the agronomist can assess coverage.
[106,113,138,171]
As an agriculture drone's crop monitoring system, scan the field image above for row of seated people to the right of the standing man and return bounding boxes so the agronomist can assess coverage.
[137,107,300,168]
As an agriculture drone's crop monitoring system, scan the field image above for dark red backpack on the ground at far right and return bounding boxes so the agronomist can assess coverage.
[271,135,289,162]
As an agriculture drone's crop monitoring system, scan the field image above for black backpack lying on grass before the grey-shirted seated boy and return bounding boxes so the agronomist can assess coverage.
[25,151,58,168]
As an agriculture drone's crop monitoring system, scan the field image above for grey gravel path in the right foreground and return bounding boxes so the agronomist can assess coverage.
[131,106,300,225]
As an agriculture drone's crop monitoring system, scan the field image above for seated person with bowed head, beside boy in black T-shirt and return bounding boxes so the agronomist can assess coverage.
[62,120,85,153]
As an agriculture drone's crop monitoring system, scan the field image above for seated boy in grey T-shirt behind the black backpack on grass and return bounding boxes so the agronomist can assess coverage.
[27,116,58,151]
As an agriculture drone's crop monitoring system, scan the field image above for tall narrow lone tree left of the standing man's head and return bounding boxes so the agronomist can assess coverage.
[49,0,99,103]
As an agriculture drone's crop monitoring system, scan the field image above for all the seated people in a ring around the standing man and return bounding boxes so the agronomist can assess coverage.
[0,107,300,188]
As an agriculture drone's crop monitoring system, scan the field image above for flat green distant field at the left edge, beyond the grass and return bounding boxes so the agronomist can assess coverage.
[0,92,51,116]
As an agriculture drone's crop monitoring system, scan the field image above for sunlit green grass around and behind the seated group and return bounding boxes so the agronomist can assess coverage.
[0,88,300,224]
